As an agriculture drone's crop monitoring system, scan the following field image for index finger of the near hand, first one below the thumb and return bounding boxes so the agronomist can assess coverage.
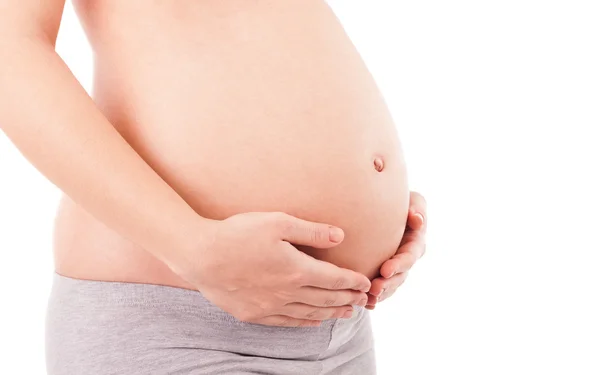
[301,255,371,293]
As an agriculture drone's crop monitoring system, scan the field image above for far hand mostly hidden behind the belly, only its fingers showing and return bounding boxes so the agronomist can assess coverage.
[366,191,427,310]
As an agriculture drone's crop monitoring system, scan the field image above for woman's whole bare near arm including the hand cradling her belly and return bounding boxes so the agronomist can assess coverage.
[0,0,371,326]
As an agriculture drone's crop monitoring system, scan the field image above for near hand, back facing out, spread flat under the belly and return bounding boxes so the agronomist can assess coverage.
[172,212,371,327]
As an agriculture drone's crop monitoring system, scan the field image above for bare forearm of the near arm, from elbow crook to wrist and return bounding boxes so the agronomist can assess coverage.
[0,37,208,264]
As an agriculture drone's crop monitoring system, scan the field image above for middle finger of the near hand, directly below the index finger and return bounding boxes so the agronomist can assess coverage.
[294,286,368,307]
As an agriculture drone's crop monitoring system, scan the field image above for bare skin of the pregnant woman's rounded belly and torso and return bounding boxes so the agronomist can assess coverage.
[54,0,409,289]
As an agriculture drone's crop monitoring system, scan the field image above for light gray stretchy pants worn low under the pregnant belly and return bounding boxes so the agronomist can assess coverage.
[46,274,375,375]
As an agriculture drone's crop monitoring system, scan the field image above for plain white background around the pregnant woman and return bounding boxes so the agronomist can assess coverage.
[0,0,600,375]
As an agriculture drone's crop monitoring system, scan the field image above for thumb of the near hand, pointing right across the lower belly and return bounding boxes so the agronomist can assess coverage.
[279,214,344,249]
